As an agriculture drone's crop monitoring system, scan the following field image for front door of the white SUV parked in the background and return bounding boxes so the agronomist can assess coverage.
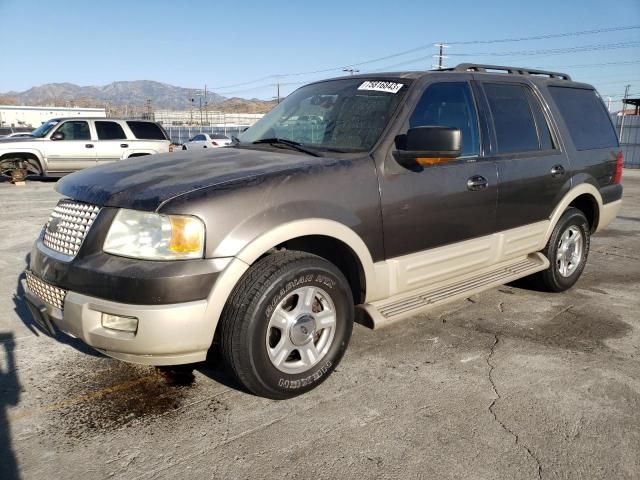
[46,120,96,172]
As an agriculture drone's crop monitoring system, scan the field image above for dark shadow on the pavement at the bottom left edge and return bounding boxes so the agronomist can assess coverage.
[0,332,20,480]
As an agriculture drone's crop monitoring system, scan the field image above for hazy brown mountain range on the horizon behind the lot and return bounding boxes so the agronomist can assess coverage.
[0,80,274,113]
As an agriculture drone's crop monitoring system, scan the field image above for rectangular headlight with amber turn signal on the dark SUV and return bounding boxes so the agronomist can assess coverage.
[102,209,204,260]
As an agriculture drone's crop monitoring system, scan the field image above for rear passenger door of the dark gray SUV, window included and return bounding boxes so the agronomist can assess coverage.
[479,80,571,231]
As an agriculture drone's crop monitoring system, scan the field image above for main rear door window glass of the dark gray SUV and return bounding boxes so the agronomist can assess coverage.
[484,83,539,153]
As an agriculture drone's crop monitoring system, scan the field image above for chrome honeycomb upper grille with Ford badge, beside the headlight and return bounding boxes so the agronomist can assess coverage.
[44,200,100,257]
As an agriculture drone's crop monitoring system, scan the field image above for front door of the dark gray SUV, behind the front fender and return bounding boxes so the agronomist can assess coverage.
[380,79,497,260]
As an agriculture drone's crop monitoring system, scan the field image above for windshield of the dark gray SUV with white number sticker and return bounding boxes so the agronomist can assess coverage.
[238,79,408,152]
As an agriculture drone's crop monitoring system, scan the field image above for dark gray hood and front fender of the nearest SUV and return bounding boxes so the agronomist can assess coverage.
[56,148,384,260]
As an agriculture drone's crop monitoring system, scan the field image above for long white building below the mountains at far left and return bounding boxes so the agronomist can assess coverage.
[0,105,107,128]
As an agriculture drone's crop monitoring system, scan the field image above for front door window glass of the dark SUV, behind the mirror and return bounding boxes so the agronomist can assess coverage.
[409,82,480,156]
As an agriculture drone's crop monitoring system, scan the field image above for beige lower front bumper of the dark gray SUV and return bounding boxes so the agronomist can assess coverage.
[22,277,213,365]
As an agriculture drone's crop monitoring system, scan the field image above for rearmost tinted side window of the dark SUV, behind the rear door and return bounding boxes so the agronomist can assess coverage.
[549,87,618,150]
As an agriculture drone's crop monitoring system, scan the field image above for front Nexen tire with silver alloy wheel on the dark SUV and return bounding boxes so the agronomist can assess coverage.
[220,251,354,400]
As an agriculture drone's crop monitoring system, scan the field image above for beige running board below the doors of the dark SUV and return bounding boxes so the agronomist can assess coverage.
[359,253,549,329]
